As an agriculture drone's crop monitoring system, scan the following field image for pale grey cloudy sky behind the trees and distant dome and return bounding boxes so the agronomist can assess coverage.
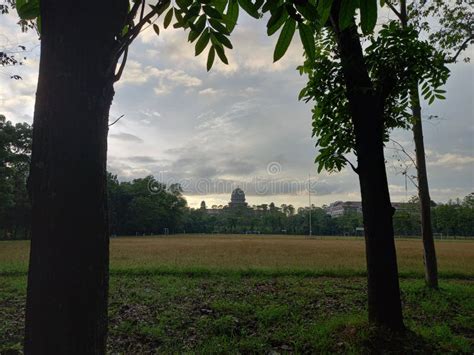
[0,8,474,207]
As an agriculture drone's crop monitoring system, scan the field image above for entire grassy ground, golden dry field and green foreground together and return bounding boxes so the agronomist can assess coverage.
[0,236,474,353]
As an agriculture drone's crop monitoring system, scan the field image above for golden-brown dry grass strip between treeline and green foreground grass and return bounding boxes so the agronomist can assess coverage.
[0,235,474,276]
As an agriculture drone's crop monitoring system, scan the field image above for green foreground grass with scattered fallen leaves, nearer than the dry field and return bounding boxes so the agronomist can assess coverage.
[0,274,474,353]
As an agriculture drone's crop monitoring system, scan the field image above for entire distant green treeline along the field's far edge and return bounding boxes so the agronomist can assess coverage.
[0,119,474,239]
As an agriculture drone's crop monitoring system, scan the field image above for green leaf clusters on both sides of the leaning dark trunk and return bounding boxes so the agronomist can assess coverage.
[299,21,449,172]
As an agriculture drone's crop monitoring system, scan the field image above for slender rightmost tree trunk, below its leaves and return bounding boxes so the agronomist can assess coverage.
[411,87,438,289]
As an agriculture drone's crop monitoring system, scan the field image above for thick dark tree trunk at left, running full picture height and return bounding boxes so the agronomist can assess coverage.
[25,0,124,354]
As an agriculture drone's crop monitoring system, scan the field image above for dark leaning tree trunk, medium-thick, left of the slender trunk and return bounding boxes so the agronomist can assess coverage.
[333,17,404,331]
